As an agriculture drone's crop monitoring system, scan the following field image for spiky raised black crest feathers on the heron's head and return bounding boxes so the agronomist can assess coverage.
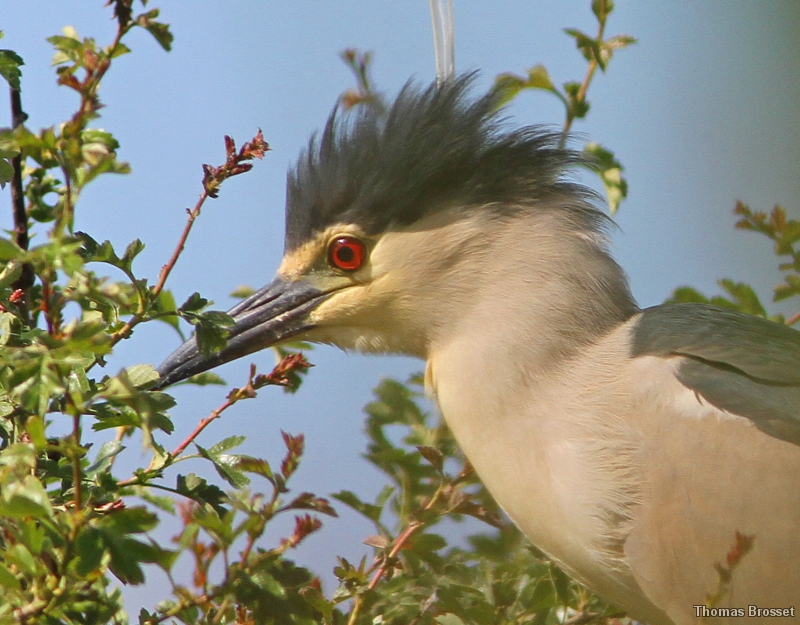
[286,74,589,251]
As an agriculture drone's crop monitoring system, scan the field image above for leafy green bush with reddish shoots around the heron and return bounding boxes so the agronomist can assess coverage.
[0,0,800,625]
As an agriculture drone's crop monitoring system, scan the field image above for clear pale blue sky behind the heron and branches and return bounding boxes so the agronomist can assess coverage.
[0,0,800,612]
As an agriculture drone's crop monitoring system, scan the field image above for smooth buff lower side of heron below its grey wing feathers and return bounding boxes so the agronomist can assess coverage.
[624,348,800,623]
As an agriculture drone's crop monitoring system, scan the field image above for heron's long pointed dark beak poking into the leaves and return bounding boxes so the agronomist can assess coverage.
[156,277,335,388]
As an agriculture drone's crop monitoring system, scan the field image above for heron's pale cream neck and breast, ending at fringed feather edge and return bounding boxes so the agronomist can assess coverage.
[426,207,636,584]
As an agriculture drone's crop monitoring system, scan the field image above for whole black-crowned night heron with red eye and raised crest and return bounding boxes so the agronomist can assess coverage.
[159,77,800,624]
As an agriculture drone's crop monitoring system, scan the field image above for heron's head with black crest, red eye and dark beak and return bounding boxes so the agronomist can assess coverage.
[159,76,627,386]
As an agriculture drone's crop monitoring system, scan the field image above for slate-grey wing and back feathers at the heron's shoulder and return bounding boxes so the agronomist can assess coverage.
[632,304,800,445]
